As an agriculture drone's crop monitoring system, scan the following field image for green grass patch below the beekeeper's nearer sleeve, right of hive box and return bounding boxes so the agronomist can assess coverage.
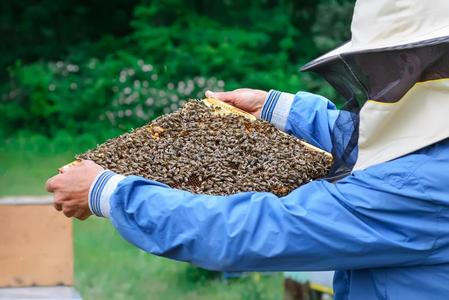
[75,218,282,300]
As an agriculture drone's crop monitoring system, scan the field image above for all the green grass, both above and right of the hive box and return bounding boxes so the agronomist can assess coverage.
[0,145,282,300]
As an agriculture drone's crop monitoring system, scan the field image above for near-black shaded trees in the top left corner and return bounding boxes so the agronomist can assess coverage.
[0,0,139,78]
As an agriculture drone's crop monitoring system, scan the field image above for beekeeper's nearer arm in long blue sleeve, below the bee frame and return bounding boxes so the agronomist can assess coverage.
[89,159,442,271]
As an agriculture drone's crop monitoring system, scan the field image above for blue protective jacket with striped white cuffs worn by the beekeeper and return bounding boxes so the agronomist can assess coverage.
[89,91,449,300]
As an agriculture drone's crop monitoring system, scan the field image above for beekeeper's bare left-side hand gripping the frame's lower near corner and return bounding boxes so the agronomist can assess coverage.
[45,160,104,220]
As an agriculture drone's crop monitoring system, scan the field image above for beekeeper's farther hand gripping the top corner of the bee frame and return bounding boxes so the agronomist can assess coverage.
[206,89,268,118]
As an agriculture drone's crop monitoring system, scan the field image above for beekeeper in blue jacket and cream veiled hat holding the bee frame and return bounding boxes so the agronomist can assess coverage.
[47,0,449,300]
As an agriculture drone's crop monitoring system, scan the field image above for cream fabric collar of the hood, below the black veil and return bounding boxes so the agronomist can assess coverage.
[354,79,449,170]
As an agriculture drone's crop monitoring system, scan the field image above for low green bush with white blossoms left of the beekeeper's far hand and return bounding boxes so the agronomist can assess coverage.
[0,52,224,139]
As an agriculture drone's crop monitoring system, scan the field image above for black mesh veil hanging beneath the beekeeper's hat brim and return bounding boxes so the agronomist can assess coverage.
[302,37,449,179]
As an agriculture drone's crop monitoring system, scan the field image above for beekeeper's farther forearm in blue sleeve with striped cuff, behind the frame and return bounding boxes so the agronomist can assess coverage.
[261,90,353,152]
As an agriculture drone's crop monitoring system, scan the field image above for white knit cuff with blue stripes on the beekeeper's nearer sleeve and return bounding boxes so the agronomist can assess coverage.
[89,170,125,218]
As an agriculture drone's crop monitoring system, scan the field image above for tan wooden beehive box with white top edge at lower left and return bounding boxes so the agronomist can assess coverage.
[0,197,73,287]
